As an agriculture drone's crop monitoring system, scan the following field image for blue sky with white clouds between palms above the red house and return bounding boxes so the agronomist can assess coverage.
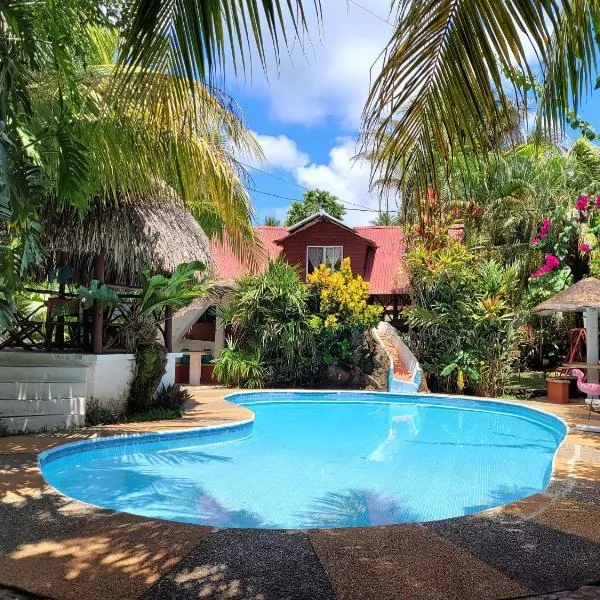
[226,0,600,225]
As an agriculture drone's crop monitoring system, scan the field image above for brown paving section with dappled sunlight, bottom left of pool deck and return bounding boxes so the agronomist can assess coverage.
[0,511,210,600]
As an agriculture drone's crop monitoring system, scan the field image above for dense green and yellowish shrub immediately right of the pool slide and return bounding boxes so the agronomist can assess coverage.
[404,239,518,396]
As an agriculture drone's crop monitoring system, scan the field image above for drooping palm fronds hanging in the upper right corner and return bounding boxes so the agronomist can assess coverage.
[363,0,600,211]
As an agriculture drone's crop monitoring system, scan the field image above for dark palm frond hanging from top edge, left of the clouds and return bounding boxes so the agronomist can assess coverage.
[121,0,321,81]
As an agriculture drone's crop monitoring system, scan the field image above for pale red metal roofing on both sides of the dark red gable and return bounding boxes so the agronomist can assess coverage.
[212,220,408,294]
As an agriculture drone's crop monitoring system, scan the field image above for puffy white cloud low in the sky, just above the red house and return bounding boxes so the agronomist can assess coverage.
[294,139,379,225]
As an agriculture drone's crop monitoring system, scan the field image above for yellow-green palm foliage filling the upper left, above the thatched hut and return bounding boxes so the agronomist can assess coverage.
[0,0,319,279]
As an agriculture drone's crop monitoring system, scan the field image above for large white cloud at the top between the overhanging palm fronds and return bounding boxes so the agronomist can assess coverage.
[231,0,393,131]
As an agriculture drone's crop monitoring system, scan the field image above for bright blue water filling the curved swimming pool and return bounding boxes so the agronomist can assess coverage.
[40,393,566,529]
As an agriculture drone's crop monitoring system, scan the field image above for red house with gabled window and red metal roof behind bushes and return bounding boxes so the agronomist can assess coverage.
[213,213,408,305]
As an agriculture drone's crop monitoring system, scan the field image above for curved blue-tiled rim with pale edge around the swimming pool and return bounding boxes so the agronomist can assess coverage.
[38,390,570,531]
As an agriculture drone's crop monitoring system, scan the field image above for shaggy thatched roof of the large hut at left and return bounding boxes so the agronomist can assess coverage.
[43,183,215,287]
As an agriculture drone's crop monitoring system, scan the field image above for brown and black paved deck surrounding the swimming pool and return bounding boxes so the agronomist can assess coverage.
[0,388,600,600]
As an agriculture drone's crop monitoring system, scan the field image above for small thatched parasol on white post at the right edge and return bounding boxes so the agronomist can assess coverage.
[533,277,600,400]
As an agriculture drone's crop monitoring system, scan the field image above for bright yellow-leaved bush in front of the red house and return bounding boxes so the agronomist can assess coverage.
[306,258,381,331]
